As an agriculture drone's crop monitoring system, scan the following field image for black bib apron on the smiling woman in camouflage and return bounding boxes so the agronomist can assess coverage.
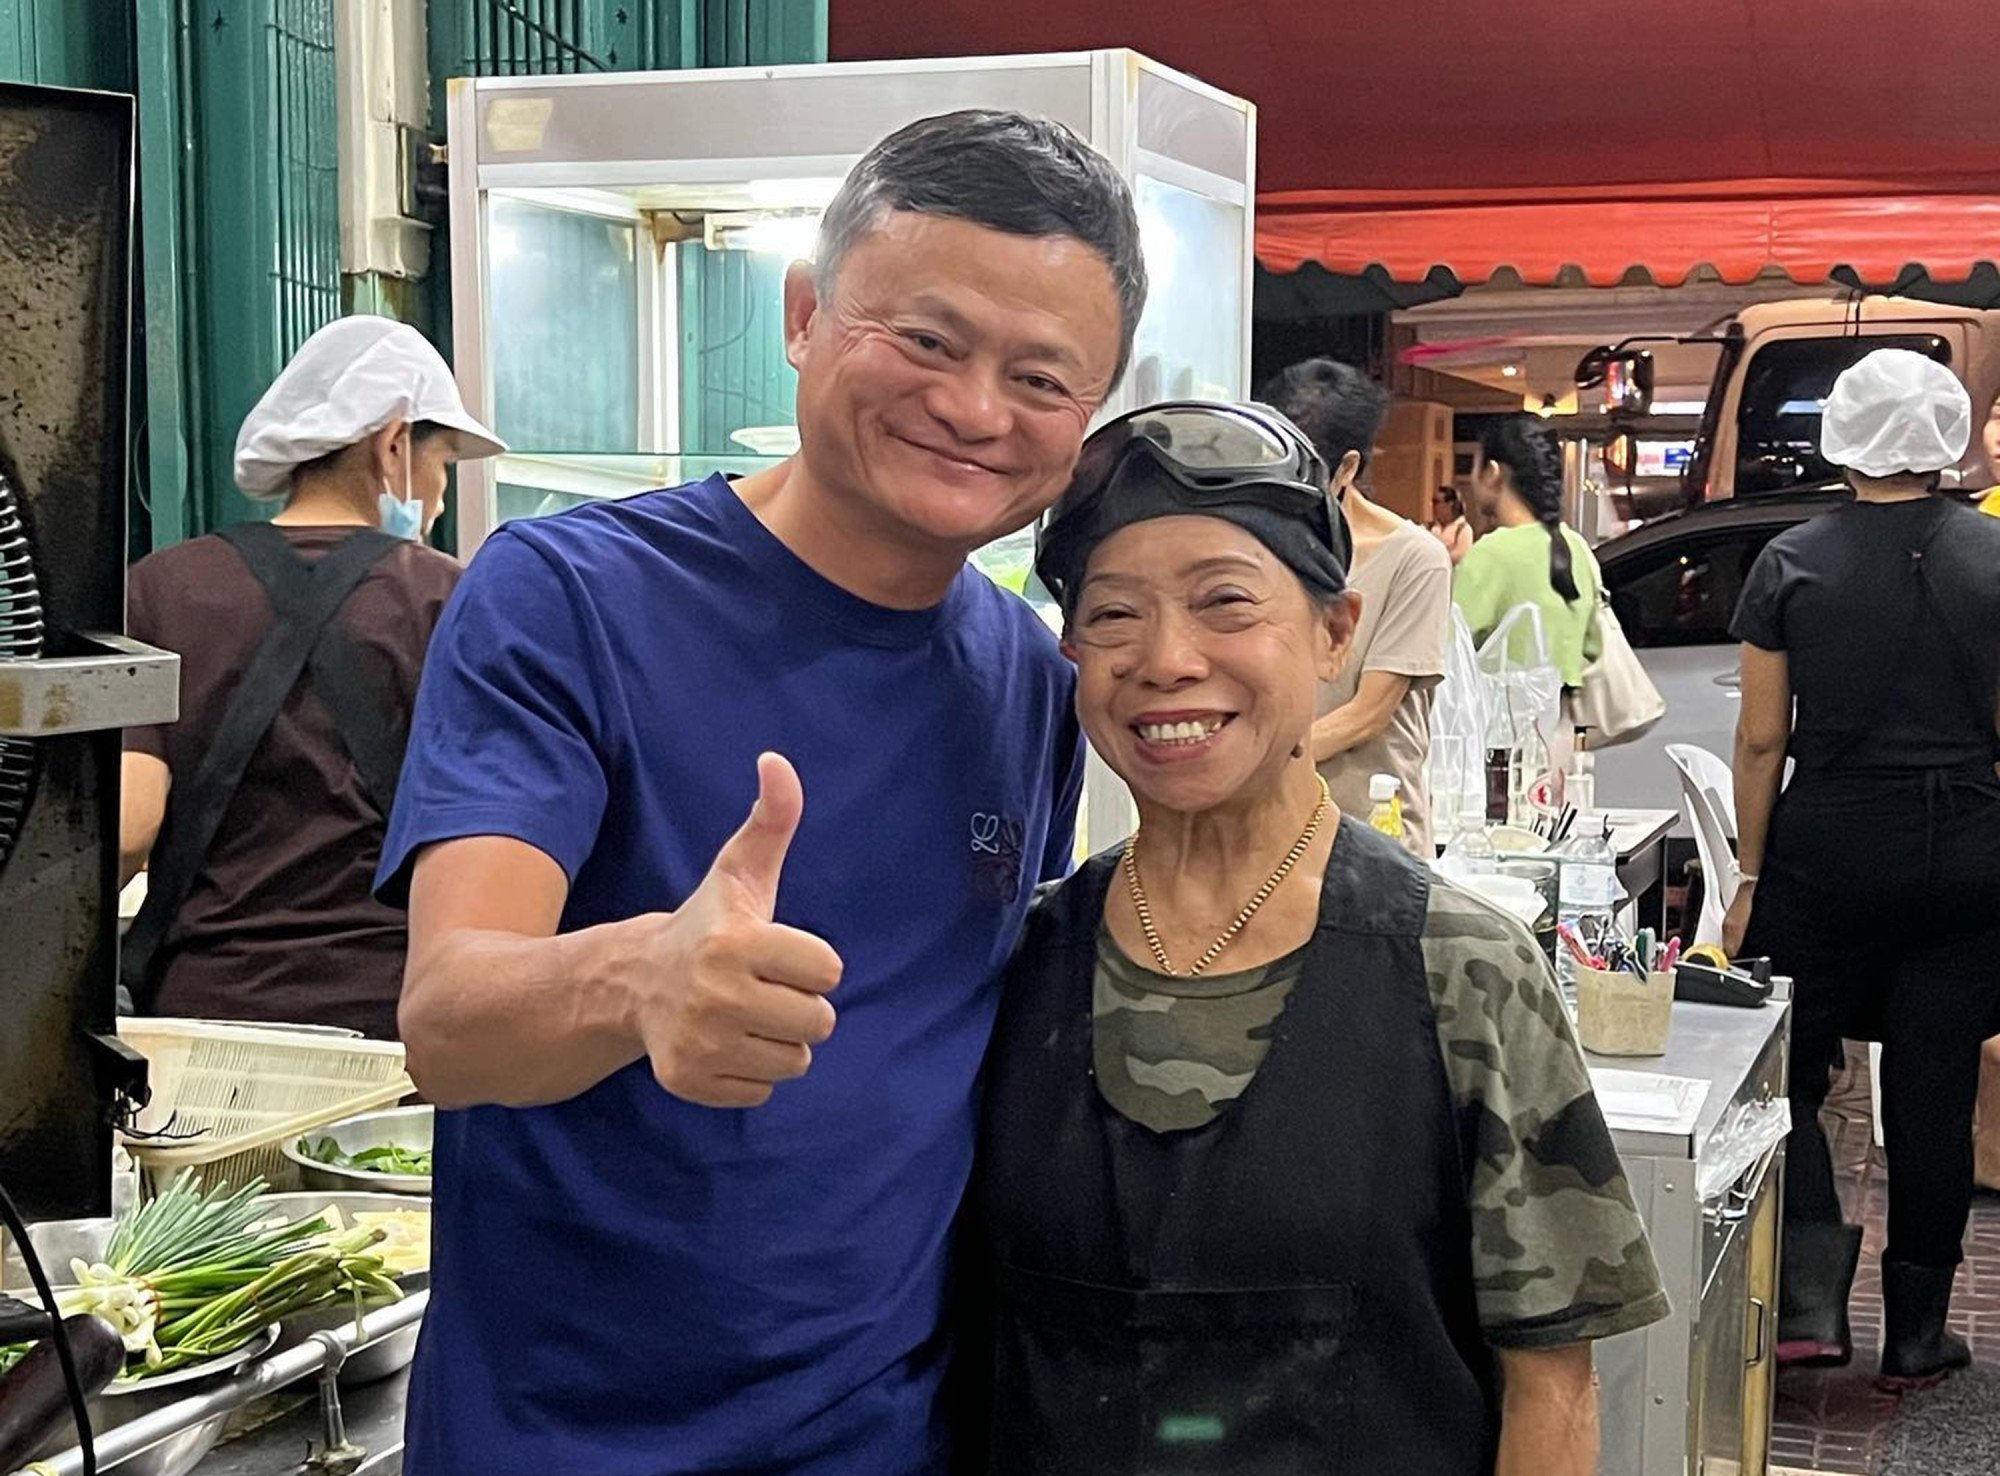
[966,820,1500,1476]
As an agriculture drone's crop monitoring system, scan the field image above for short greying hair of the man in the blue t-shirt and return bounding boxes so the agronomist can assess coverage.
[814,110,1146,384]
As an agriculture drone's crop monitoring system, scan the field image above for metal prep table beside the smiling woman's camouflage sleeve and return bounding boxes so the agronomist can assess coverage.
[1588,998,1790,1476]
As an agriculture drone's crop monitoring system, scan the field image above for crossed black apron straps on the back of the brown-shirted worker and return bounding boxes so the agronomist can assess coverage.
[118,522,410,1014]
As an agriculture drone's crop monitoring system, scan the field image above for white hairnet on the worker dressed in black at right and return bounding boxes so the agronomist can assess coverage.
[1820,348,1972,476]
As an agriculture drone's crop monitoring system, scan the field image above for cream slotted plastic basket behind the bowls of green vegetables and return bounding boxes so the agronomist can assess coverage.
[118,1016,416,1190]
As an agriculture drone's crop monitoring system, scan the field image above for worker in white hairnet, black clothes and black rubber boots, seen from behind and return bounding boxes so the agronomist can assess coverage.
[1724,348,2000,1386]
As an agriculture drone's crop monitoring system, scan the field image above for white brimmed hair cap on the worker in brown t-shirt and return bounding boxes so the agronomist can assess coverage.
[236,314,506,498]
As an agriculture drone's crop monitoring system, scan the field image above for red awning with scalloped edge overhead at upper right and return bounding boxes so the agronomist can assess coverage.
[830,0,2000,282]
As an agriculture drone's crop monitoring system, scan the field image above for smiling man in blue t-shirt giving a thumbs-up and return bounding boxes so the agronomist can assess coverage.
[380,112,1146,1476]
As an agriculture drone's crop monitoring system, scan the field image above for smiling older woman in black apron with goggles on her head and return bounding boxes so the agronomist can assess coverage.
[980,404,1666,1476]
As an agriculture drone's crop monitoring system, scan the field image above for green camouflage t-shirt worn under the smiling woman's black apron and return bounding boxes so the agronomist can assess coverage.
[1092,880,1668,1348]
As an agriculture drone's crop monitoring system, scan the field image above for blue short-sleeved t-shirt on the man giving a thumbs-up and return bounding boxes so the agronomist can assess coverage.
[382,478,1082,1476]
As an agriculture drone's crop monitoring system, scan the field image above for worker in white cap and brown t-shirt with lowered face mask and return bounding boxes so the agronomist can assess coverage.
[120,316,504,1036]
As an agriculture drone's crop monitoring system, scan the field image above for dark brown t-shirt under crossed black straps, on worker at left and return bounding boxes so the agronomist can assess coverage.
[124,528,460,1038]
